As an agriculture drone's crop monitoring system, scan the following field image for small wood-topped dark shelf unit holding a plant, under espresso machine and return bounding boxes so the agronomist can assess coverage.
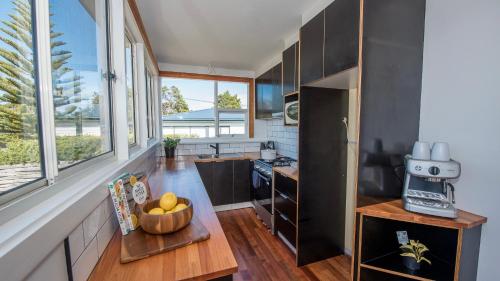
[353,200,486,281]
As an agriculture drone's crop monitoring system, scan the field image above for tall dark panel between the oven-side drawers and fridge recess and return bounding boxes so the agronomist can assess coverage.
[297,87,349,266]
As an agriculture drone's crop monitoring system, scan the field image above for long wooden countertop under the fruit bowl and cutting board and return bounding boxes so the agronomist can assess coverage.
[89,156,238,281]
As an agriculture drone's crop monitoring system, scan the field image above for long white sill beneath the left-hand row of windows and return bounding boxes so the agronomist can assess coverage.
[0,142,158,280]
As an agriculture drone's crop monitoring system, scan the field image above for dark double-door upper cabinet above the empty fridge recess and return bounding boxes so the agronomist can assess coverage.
[300,0,360,89]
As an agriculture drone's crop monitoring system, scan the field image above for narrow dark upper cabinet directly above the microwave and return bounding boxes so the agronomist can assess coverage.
[283,42,299,95]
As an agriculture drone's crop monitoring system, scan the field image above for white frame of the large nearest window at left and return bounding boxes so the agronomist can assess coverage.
[0,0,116,203]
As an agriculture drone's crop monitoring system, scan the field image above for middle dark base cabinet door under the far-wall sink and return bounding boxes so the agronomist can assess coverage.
[212,161,234,206]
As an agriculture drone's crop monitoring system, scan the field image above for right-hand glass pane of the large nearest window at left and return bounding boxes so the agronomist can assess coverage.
[49,0,112,168]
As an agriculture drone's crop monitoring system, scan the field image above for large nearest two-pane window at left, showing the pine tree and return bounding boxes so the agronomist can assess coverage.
[0,0,113,203]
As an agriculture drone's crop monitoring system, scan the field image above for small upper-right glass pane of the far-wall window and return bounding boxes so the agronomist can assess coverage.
[217,81,248,110]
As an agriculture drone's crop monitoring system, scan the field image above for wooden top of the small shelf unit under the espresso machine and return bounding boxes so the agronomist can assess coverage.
[356,199,487,229]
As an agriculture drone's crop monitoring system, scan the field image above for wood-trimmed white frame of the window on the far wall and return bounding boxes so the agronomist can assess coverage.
[160,71,255,140]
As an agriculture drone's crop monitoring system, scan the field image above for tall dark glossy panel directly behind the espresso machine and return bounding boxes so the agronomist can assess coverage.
[358,0,425,207]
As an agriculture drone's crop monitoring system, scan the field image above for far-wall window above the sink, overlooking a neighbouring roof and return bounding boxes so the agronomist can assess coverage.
[161,77,249,139]
